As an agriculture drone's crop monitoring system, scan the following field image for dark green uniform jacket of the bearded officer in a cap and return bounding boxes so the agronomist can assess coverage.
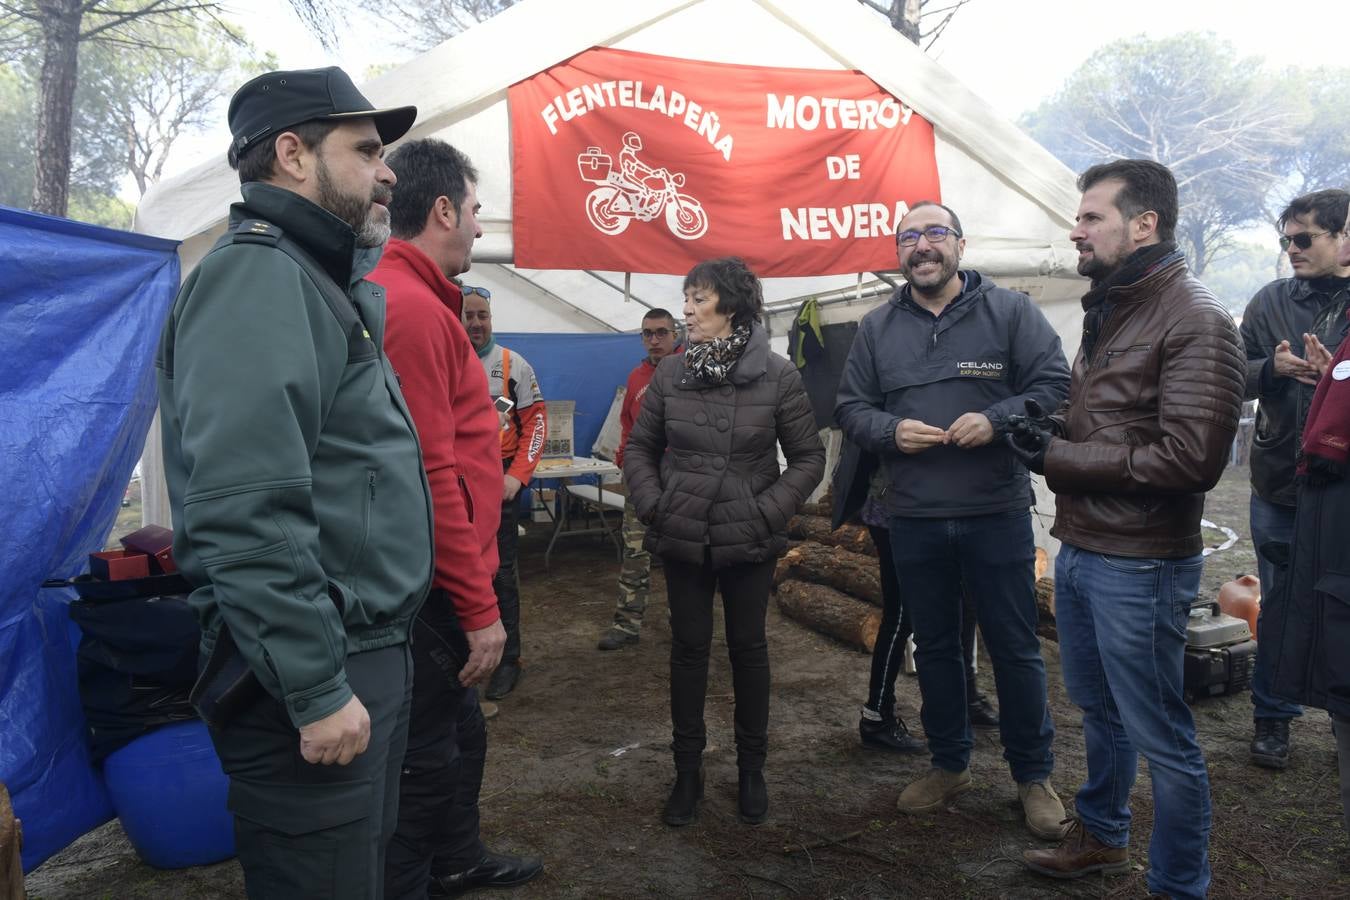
[155,182,433,727]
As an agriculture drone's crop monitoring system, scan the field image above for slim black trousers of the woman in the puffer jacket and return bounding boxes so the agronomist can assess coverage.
[664,559,775,772]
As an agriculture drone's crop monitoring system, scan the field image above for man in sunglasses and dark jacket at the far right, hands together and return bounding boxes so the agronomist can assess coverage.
[1241,190,1350,769]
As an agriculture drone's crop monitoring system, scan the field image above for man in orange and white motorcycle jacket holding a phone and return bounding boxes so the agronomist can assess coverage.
[463,285,548,700]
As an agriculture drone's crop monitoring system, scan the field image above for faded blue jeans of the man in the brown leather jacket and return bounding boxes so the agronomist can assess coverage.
[1054,544,1210,897]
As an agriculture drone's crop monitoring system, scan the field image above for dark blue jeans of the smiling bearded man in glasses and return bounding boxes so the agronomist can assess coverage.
[890,511,1054,783]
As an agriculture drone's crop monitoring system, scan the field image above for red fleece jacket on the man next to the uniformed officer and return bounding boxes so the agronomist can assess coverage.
[370,239,502,631]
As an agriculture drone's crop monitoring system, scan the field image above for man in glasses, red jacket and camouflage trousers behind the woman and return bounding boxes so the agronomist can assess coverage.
[599,308,679,650]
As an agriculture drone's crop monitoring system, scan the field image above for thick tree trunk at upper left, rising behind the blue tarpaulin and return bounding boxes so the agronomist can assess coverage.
[32,0,84,216]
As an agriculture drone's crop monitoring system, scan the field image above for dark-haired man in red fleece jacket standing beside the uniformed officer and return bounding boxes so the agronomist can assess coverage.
[370,139,543,900]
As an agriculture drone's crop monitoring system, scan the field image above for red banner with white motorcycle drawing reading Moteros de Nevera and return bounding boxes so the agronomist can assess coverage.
[508,49,941,277]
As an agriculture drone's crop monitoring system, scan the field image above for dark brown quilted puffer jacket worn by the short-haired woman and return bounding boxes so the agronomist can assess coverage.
[624,324,825,569]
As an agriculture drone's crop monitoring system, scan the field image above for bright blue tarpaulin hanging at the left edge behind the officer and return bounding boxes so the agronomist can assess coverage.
[0,206,178,872]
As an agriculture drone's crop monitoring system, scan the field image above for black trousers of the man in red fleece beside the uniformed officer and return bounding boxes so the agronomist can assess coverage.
[385,591,487,900]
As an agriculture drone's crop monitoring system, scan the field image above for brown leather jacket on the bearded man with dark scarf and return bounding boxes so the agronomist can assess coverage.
[1045,253,1246,559]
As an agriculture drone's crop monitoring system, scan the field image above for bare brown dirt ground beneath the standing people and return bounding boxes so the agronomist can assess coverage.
[27,468,1350,900]
